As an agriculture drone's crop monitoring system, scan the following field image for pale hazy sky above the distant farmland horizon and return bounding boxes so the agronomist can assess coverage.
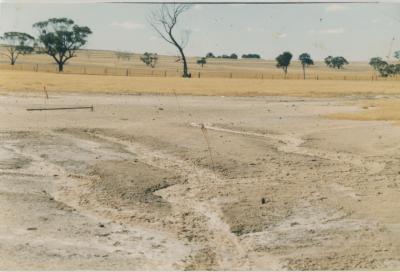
[0,0,400,61]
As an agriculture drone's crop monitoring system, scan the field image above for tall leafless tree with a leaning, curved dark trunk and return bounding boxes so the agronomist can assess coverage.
[148,4,191,77]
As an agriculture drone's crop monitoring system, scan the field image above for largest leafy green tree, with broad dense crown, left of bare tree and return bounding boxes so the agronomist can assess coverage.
[33,18,92,72]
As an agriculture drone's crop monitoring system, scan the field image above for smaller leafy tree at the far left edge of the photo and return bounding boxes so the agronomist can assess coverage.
[0,32,35,65]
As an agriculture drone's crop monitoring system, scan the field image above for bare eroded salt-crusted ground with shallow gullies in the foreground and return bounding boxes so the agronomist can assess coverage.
[0,93,400,270]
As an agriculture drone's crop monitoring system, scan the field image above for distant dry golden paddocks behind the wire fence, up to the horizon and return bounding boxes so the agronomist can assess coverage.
[0,48,390,80]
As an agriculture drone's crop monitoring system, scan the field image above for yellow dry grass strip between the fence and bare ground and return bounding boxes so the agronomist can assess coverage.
[0,70,400,97]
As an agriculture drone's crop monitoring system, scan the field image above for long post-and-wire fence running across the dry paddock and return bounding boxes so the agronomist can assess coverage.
[0,63,400,81]
